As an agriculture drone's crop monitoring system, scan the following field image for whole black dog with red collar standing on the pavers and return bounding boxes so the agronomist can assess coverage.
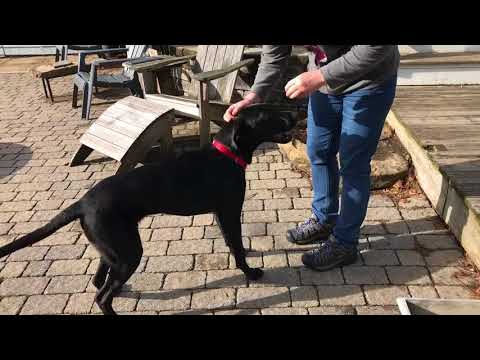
[0,104,298,315]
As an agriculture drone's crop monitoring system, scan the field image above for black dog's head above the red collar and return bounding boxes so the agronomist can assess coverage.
[234,104,299,145]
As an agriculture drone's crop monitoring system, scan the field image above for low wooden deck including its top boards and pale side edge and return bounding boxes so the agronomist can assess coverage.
[387,85,480,267]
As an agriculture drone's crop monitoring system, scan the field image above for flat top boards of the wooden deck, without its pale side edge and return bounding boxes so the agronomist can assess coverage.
[392,86,480,200]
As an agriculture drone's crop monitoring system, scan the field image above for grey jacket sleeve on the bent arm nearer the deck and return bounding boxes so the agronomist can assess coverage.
[321,45,395,89]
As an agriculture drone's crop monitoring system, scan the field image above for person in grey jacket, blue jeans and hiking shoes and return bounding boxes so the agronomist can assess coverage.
[224,45,400,271]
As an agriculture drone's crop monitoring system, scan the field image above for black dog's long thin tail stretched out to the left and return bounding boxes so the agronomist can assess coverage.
[0,202,82,258]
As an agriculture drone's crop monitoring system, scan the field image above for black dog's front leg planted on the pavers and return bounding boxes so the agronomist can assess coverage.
[215,209,263,280]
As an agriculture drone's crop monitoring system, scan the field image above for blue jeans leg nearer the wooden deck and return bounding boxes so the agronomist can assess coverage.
[333,76,396,245]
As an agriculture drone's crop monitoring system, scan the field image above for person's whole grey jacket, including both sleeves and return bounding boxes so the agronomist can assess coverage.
[252,45,400,100]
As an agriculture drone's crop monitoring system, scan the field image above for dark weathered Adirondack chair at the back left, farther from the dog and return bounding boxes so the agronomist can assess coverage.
[72,45,152,120]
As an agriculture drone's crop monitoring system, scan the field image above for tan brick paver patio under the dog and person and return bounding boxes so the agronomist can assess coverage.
[0,74,472,315]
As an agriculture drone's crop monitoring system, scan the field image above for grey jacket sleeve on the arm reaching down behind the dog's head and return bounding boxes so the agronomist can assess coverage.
[251,45,292,100]
